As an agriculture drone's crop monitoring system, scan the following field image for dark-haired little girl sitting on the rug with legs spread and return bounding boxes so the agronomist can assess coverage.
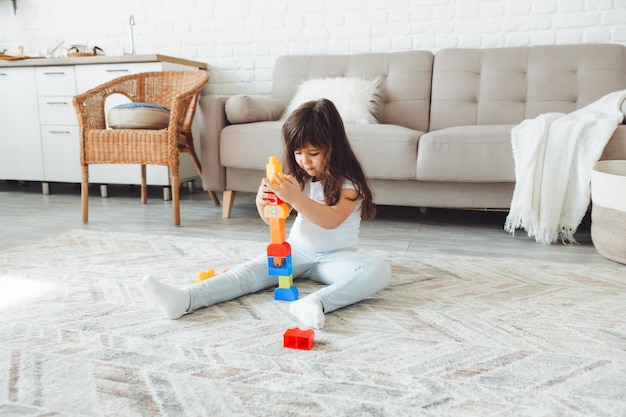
[141,99,391,329]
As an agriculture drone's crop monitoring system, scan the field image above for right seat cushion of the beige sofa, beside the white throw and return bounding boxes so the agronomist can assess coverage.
[417,125,515,182]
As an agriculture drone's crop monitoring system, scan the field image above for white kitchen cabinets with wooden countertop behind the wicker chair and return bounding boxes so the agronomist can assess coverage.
[0,55,206,196]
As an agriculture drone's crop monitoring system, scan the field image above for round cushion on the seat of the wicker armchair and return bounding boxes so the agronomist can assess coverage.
[107,103,170,130]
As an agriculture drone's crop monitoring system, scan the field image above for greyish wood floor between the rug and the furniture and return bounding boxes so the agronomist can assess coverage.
[0,181,619,267]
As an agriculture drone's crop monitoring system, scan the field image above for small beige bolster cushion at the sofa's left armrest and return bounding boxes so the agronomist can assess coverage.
[225,94,285,124]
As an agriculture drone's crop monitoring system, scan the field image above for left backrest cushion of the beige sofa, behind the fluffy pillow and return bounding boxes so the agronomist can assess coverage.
[272,51,433,132]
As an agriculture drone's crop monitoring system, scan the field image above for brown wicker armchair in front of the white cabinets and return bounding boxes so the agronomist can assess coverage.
[74,70,214,226]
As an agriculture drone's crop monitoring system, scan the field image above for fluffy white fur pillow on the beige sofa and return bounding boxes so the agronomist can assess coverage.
[282,77,382,124]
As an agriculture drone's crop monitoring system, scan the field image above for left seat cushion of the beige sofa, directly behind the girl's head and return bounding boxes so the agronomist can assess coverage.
[220,122,422,180]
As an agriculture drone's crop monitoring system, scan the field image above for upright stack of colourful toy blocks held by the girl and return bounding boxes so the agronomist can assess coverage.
[263,156,298,301]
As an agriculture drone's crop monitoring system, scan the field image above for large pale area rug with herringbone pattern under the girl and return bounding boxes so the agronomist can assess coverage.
[0,230,626,417]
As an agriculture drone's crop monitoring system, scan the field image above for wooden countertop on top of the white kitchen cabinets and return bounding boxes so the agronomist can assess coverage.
[0,54,207,69]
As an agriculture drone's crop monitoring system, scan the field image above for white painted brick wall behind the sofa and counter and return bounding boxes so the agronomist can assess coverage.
[0,0,626,94]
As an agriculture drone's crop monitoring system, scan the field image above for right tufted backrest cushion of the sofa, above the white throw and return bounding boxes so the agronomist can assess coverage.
[429,44,626,131]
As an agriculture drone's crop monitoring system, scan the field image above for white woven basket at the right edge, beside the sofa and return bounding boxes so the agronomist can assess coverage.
[591,160,626,264]
